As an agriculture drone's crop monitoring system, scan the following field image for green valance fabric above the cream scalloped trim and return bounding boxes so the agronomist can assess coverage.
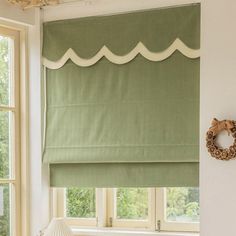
[43,4,200,61]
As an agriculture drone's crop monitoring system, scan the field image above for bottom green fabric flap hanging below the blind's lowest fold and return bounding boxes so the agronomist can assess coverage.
[50,163,199,188]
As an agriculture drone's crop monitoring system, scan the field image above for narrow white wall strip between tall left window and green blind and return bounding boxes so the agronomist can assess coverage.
[28,9,45,236]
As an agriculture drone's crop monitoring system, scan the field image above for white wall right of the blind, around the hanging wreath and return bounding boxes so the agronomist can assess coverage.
[200,0,236,236]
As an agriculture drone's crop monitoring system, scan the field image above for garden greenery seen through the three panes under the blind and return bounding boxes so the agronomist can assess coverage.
[66,187,200,226]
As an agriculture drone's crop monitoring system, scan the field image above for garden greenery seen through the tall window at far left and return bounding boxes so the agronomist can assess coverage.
[0,35,12,236]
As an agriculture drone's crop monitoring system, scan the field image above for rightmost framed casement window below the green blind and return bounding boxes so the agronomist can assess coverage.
[156,188,200,231]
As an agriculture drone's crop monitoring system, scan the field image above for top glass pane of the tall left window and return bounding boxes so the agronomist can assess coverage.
[0,35,12,105]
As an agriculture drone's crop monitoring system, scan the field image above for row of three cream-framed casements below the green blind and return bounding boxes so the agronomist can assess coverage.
[54,187,199,232]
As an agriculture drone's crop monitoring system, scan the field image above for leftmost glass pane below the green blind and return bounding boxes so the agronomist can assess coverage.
[66,188,96,218]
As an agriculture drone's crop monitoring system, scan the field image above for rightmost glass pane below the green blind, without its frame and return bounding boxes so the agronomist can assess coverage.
[166,188,200,223]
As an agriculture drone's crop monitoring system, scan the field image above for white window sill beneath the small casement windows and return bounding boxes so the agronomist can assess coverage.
[72,228,199,236]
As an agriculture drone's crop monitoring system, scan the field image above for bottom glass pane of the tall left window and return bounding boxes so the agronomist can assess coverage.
[0,184,11,236]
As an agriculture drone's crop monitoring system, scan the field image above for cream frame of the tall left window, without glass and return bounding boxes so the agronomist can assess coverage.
[0,19,30,236]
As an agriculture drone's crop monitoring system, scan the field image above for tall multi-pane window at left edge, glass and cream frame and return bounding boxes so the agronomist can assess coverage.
[0,27,20,236]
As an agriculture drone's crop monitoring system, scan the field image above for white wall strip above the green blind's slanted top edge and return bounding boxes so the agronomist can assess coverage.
[44,0,201,21]
